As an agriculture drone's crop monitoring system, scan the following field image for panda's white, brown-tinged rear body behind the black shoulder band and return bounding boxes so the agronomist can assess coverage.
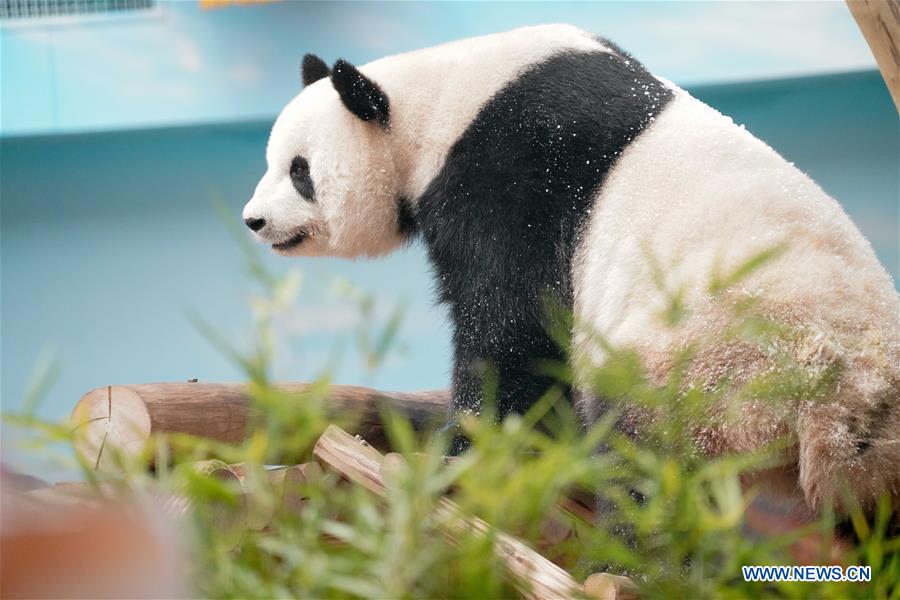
[573,89,900,508]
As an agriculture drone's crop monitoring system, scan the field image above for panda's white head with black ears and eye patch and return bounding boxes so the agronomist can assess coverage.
[243,54,406,257]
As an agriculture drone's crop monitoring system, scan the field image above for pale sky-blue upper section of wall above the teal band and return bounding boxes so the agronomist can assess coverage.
[0,0,875,135]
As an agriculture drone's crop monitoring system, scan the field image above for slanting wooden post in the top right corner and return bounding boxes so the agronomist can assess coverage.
[847,0,900,110]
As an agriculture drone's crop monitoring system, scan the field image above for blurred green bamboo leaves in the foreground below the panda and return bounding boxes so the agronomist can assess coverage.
[8,240,900,598]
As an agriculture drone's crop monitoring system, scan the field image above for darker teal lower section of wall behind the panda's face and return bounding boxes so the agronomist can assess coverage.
[0,72,900,476]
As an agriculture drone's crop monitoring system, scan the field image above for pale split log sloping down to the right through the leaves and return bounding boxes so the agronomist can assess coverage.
[313,425,584,599]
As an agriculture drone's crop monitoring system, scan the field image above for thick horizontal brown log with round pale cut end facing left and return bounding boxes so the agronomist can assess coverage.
[72,383,449,471]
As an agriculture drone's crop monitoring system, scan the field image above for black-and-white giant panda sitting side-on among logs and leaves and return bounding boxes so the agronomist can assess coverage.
[243,25,900,510]
